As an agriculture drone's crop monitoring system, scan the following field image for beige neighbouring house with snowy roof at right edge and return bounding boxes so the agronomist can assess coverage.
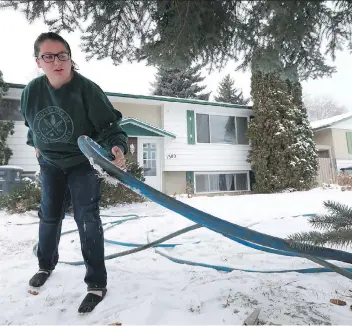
[311,112,352,183]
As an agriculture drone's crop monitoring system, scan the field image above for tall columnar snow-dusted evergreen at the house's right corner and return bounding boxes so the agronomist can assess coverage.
[248,48,317,193]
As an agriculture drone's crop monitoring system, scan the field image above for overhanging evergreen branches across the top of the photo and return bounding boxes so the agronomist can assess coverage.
[4,0,352,79]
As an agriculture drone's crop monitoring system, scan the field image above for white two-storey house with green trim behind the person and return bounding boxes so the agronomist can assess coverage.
[2,84,252,195]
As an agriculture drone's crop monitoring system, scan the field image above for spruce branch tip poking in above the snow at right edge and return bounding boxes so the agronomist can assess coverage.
[288,201,352,249]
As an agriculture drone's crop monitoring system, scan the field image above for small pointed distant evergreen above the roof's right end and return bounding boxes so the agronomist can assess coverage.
[214,74,249,105]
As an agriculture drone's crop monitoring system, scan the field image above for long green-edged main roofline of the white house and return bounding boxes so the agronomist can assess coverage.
[6,83,252,110]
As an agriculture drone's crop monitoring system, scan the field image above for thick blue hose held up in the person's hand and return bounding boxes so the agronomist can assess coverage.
[78,136,352,279]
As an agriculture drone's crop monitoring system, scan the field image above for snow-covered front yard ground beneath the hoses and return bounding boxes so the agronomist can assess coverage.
[0,189,352,325]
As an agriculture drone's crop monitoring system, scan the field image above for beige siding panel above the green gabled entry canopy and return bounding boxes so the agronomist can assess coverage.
[112,102,163,128]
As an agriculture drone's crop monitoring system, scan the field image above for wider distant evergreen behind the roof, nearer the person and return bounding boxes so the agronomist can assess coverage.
[152,65,210,101]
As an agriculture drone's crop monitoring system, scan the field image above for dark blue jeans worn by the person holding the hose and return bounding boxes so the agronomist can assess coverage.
[37,156,107,290]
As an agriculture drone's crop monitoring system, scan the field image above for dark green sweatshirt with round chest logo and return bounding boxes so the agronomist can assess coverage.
[21,71,128,168]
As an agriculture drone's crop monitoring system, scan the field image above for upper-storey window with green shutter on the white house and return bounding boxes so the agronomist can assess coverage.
[196,113,248,145]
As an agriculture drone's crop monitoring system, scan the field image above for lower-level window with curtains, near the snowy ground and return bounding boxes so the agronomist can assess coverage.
[195,172,249,193]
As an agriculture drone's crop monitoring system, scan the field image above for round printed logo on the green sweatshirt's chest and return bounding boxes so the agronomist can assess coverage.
[33,106,74,144]
